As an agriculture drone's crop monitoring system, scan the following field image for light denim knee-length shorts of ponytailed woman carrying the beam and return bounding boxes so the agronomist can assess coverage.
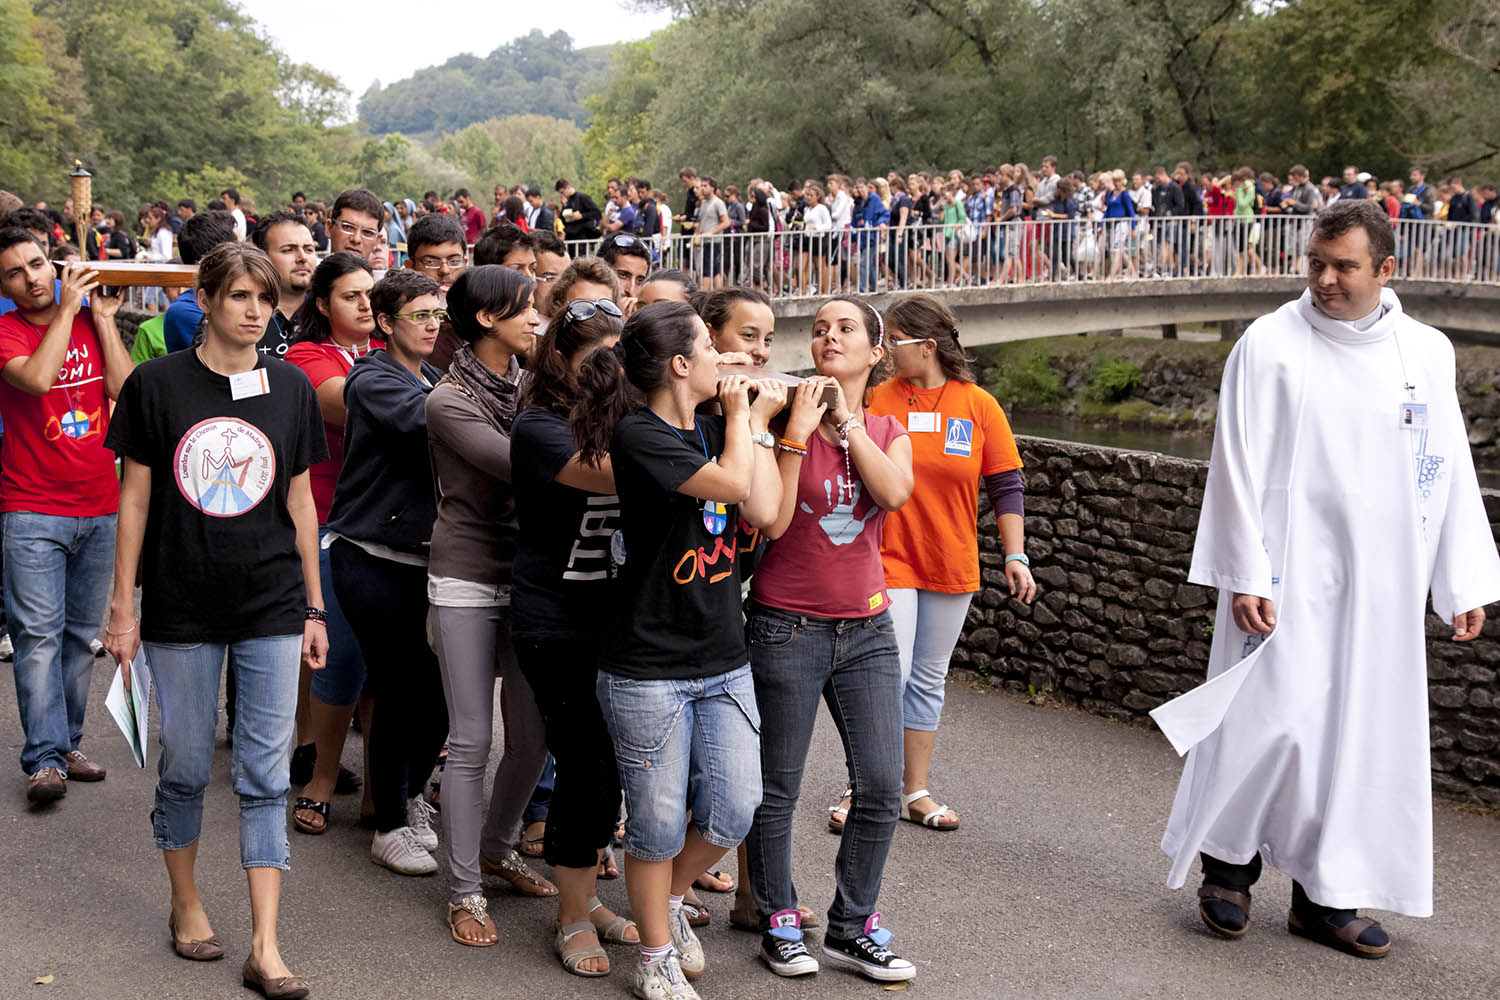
[597,664,761,861]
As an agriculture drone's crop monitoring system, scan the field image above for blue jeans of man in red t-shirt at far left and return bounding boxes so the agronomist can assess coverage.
[0,511,114,774]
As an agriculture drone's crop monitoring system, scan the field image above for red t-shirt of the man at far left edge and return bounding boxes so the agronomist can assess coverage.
[0,309,120,517]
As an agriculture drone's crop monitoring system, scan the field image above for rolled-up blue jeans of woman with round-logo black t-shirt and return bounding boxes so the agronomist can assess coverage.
[146,634,302,870]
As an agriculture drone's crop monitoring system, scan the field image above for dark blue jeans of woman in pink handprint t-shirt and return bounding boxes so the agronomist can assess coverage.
[741,604,905,937]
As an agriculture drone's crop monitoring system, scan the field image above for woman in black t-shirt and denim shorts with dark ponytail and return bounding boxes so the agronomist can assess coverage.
[564,303,786,996]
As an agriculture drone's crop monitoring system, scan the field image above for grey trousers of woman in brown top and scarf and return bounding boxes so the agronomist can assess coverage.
[428,606,548,901]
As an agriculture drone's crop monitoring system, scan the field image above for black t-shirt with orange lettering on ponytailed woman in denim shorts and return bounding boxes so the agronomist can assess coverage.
[599,409,750,681]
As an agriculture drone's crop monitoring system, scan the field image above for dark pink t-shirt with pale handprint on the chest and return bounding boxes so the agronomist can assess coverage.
[750,412,906,618]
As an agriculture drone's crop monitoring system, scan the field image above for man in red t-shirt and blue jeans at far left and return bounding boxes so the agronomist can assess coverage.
[0,228,133,802]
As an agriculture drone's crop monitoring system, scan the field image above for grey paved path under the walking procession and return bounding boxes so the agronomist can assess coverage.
[0,658,1500,1000]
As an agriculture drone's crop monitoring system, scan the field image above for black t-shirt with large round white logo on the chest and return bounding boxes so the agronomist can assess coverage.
[105,351,329,643]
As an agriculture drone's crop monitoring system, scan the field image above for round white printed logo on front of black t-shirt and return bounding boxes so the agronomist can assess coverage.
[173,417,276,517]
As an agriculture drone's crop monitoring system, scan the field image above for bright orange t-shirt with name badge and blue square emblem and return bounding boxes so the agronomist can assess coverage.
[870,378,1022,594]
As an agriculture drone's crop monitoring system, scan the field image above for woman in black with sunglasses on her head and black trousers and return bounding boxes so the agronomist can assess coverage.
[510,300,641,976]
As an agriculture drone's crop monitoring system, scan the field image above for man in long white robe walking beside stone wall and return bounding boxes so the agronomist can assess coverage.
[1152,201,1500,958]
